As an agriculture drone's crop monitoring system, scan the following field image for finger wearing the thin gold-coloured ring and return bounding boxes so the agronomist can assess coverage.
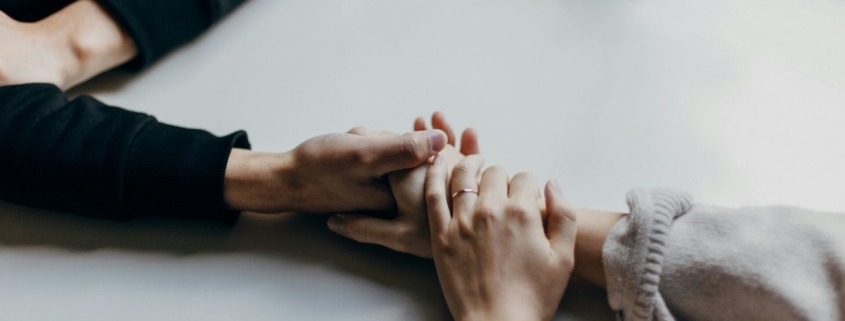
[449,155,484,217]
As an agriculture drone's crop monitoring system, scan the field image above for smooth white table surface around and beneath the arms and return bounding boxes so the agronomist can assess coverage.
[0,0,845,320]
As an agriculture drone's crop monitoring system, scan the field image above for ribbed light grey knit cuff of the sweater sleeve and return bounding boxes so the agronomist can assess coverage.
[602,189,692,321]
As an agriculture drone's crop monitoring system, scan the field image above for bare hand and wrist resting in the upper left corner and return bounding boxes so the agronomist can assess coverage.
[0,1,137,89]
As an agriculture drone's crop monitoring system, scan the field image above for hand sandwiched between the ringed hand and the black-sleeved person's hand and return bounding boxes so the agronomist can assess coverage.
[328,112,479,258]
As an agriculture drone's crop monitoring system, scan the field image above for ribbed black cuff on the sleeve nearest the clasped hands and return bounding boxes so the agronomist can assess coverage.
[124,121,250,225]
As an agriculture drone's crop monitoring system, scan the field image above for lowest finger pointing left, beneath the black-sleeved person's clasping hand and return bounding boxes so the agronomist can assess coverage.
[328,214,397,250]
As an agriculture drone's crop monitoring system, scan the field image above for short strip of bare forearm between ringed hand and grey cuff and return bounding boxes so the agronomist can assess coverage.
[572,208,624,287]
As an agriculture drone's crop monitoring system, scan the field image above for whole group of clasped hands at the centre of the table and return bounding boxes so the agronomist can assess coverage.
[225,113,576,320]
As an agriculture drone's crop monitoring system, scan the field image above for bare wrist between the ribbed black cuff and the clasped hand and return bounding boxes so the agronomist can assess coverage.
[223,148,294,213]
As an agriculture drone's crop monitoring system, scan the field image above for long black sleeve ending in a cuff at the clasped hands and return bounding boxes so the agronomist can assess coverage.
[0,84,249,224]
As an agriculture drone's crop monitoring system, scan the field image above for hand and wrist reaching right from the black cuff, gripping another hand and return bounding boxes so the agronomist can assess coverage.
[224,129,447,213]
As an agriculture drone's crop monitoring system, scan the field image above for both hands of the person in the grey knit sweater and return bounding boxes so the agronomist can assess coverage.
[329,113,576,320]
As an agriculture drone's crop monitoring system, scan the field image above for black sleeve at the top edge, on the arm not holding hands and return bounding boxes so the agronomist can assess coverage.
[97,0,245,69]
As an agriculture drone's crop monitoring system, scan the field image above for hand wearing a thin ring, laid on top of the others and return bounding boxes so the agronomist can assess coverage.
[426,155,576,320]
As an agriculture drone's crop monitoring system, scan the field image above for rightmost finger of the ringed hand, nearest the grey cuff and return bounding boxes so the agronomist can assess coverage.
[546,180,578,252]
